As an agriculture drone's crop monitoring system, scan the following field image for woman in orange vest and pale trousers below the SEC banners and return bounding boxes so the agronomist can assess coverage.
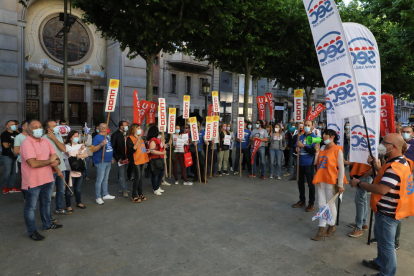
[311,129,346,241]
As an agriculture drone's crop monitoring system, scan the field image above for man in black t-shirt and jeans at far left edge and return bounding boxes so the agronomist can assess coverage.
[0,120,21,194]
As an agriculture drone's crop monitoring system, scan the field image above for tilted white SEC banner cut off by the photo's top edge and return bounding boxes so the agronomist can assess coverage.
[303,0,362,119]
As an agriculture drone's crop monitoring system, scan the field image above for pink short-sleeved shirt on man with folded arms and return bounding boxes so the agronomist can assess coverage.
[20,136,56,190]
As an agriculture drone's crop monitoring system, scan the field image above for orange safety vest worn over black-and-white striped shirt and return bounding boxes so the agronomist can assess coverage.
[370,158,414,220]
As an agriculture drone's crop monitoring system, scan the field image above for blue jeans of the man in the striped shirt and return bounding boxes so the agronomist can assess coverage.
[374,212,399,276]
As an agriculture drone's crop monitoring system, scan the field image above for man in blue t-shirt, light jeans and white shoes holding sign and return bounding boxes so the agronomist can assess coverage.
[91,124,115,205]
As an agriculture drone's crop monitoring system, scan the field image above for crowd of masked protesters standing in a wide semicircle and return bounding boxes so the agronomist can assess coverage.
[1,117,414,275]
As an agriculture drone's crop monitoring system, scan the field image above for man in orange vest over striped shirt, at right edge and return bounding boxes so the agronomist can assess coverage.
[350,133,414,276]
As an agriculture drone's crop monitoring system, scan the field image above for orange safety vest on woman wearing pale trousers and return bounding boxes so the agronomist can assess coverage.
[312,145,347,185]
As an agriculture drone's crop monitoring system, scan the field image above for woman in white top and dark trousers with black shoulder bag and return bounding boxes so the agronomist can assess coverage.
[63,130,88,212]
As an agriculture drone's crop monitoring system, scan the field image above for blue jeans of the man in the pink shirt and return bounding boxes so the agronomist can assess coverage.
[24,182,53,236]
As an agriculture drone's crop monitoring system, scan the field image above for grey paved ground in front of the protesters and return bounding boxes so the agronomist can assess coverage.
[0,166,414,276]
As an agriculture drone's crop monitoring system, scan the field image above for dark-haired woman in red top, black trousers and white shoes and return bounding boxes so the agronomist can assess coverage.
[147,126,166,195]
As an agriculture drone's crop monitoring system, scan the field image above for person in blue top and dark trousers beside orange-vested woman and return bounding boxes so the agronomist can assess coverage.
[292,121,317,212]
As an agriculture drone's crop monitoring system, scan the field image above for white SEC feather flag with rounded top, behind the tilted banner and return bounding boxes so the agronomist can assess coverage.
[342,23,381,164]
